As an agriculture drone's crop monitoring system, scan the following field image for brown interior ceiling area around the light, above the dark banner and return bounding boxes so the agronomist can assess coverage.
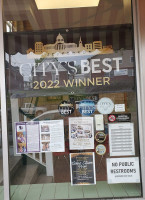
[4,0,132,30]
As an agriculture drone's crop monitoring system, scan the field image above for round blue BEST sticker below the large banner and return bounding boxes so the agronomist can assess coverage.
[79,100,96,116]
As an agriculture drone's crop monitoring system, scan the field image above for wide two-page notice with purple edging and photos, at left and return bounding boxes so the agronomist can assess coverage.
[15,120,65,154]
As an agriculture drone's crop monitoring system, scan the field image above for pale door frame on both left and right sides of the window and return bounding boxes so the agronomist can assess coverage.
[0,0,145,200]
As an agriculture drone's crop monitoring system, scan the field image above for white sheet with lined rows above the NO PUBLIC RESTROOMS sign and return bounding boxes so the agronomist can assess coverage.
[109,123,135,156]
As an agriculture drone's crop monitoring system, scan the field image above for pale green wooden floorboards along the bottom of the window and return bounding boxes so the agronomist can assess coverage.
[8,181,141,200]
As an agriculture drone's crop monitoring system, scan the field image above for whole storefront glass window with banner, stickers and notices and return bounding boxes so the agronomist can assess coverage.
[4,0,142,200]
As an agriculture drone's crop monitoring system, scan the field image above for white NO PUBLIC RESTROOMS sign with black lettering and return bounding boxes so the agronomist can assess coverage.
[107,157,140,184]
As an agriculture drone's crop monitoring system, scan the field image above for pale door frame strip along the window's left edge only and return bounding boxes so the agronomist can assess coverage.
[0,0,10,200]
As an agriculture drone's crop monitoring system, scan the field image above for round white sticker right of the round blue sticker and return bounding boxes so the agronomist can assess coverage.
[97,97,114,115]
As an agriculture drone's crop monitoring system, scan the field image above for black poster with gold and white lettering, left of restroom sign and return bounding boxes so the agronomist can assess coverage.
[70,152,96,185]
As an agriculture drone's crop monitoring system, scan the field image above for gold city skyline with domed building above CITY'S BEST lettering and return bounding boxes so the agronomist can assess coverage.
[27,33,113,57]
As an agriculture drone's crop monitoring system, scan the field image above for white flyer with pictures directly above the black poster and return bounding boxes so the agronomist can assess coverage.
[69,117,94,150]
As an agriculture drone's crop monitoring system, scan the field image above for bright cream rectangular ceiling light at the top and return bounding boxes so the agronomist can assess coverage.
[35,0,100,9]
